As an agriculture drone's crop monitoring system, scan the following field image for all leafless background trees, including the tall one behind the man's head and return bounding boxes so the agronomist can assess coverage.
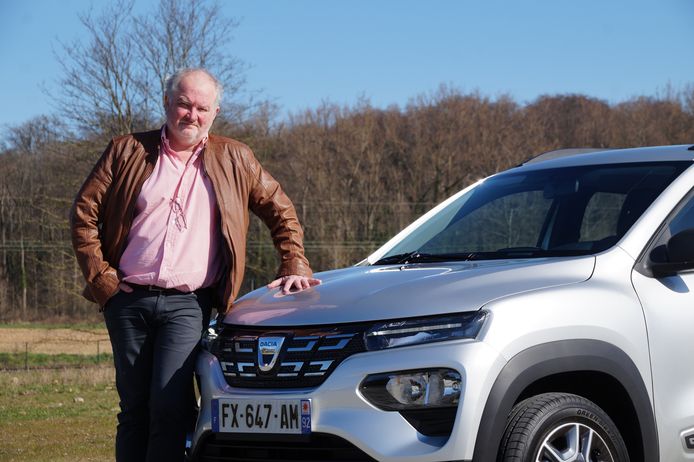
[0,0,694,322]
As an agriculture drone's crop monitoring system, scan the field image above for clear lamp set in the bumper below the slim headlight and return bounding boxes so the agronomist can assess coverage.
[359,369,462,411]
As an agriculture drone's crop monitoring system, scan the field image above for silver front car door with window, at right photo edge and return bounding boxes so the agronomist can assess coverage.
[632,192,694,462]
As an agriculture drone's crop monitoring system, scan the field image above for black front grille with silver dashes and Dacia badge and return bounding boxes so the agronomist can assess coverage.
[210,324,370,388]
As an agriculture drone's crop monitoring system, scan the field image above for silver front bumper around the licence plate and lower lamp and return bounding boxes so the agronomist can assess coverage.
[192,340,505,462]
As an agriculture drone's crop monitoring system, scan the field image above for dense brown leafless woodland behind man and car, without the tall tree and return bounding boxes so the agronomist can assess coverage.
[0,88,694,321]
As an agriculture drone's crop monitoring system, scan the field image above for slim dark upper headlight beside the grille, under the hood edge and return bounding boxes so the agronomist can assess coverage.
[365,311,487,350]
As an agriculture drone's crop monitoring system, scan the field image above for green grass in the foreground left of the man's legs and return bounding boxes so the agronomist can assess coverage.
[0,366,118,462]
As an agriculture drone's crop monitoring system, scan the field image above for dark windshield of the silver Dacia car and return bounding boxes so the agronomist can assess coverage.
[376,162,690,264]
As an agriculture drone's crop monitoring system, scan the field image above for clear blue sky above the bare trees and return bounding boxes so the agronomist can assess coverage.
[0,0,694,127]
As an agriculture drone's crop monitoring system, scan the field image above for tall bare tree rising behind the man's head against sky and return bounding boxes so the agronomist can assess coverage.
[51,0,246,136]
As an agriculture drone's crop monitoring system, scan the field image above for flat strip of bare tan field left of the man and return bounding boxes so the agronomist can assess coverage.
[0,327,111,355]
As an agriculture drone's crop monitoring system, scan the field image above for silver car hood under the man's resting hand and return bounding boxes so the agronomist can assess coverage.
[223,256,595,327]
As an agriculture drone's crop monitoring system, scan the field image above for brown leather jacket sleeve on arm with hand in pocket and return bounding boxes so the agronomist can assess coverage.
[70,141,119,307]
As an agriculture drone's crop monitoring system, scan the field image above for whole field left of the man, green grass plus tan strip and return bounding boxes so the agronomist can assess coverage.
[0,326,118,462]
